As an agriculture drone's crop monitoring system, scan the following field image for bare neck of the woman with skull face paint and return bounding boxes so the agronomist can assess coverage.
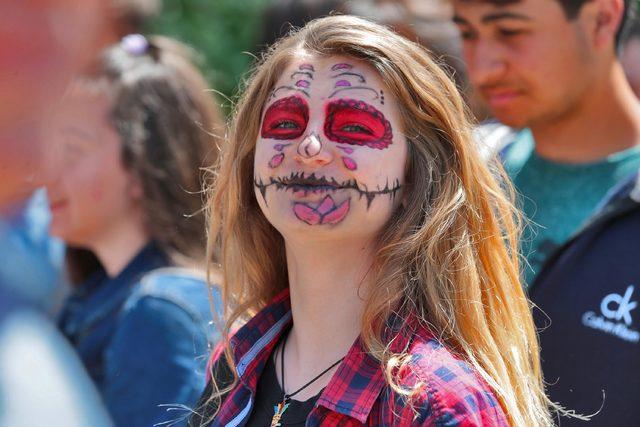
[285,237,373,402]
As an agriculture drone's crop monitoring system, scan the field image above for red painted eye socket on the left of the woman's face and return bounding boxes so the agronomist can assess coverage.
[260,96,309,139]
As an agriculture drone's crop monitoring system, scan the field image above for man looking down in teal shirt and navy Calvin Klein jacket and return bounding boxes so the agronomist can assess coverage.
[454,0,640,425]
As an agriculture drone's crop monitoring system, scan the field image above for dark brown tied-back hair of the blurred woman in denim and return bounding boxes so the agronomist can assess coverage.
[67,35,224,283]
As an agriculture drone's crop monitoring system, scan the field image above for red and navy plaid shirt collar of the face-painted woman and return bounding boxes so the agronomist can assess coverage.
[231,288,409,423]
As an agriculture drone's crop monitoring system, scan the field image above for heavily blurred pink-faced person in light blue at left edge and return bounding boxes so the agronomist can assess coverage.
[0,0,160,316]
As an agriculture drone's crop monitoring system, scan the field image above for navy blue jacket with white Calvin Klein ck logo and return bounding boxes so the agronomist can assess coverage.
[529,171,640,426]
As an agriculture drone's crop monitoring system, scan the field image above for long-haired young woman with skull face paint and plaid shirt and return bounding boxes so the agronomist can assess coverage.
[191,16,551,426]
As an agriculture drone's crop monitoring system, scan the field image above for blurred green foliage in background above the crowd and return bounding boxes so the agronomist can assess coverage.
[147,0,268,111]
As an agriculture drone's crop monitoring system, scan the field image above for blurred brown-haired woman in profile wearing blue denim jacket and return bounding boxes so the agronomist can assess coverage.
[47,34,223,427]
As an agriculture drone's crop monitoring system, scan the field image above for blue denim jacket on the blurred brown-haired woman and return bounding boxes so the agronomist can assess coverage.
[60,243,220,427]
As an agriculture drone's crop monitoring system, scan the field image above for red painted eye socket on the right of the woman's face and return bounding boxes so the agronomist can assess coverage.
[324,99,393,150]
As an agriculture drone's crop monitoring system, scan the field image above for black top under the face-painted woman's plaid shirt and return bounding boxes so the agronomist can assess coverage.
[246,350,320,427]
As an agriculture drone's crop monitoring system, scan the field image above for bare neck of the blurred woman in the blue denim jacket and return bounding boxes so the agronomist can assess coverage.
[90,217,150,277]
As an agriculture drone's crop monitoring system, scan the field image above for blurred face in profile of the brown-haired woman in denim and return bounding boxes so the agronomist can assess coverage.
[47,89,139,247]
